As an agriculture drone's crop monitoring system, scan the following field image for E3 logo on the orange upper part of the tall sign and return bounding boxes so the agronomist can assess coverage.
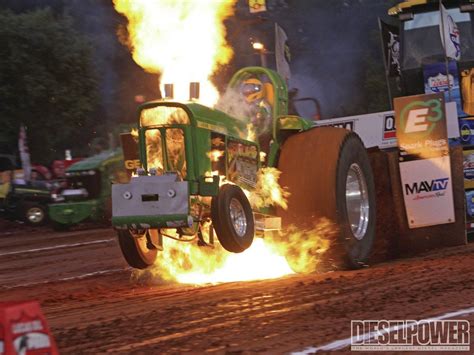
[400,99,443,138]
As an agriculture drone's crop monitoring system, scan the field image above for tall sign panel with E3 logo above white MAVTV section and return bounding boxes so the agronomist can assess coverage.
[394,93,455,228]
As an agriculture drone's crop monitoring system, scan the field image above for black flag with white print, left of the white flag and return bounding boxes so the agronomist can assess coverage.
[379,19,401,77]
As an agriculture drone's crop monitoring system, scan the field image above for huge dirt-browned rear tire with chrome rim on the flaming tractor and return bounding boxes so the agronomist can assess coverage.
[277,127,375,271]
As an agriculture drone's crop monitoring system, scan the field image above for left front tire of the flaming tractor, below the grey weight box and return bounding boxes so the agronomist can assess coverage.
[118,229,159,269]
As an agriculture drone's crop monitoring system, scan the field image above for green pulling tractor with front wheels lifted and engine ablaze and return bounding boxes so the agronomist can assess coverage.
[112,67,375,269]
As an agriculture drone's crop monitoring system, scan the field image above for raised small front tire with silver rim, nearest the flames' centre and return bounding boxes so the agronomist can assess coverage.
[211,184,255,253]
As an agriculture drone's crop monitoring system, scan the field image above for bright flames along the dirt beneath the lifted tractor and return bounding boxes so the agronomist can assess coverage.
[132,220,337,285]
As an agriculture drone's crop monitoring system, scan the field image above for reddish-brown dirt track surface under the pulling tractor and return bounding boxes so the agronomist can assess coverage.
[0,224,474,354]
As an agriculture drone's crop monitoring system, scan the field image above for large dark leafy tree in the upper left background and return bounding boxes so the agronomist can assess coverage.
[0,9,100,164]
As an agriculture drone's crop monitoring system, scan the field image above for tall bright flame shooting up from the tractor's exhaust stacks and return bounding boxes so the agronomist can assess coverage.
[113,0,236,106]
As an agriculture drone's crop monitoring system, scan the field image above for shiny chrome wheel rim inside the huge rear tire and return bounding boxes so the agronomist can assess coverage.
[346,163,369,240]
